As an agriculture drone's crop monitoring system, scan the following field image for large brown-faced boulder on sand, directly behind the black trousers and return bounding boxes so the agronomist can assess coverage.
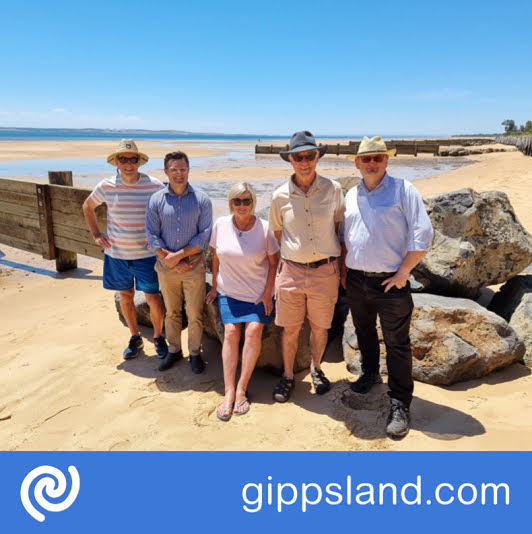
[343,294,525,386]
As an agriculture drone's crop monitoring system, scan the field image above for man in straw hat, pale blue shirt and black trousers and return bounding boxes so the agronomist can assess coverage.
[341,136,433,438]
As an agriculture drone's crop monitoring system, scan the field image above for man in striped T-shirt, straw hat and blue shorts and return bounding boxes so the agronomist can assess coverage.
[83,139,168,359]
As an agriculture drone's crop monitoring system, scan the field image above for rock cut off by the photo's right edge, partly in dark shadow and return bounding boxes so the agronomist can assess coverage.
[488,274,532,367]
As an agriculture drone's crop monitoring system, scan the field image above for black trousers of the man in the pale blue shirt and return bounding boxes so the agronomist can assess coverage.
[347,269,414,406]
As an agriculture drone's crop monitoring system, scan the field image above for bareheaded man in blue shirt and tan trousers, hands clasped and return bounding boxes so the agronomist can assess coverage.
[146,152,212,374]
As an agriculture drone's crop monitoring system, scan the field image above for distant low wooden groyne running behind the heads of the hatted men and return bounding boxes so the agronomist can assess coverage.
[255,137,495,156]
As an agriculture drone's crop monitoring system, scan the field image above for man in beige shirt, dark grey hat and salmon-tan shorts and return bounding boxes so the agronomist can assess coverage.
[270,131,344,402]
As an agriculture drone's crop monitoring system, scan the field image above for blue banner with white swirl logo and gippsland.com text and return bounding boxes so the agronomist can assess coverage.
[0,452,532,534]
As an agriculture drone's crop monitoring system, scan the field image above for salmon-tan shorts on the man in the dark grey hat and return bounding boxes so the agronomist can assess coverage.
[275,259,340,329]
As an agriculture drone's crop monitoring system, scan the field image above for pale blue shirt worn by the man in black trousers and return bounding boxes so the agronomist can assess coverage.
[344,174,434,273]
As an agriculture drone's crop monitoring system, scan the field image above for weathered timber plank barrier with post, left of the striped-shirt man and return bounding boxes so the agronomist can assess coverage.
[0,171,107,272]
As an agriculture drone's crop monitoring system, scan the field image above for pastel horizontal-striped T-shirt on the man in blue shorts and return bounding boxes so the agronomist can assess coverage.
[90,172,164,260]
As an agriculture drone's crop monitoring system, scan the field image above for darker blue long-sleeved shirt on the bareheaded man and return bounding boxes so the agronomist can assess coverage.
[146,184,212,252]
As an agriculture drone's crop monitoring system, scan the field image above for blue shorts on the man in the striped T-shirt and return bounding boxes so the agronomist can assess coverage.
[103,254,159,293]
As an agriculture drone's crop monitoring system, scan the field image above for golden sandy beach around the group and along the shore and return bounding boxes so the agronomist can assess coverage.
[0,140,532,451]
